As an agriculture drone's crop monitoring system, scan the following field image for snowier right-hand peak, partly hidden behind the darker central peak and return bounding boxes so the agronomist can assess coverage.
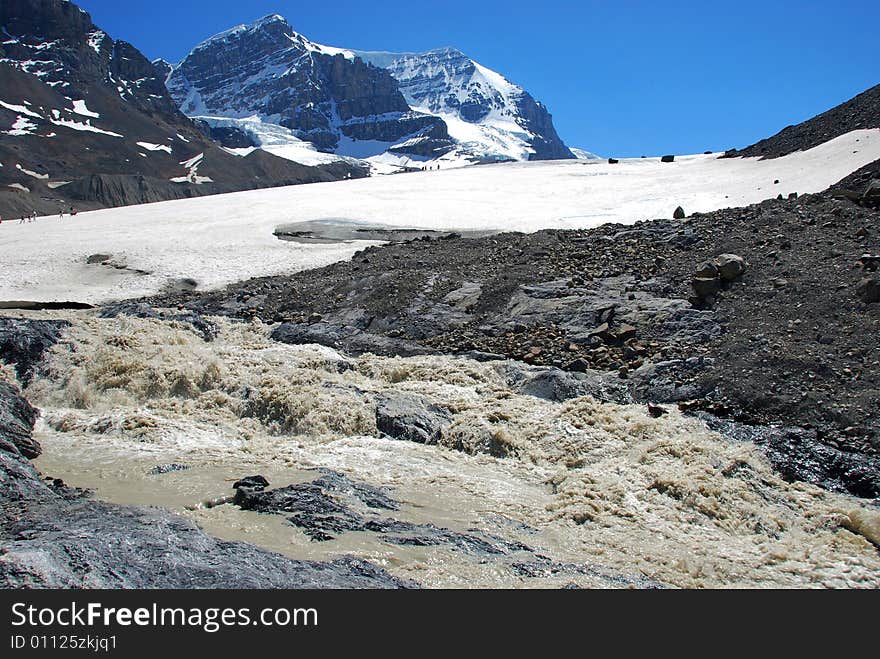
[354,48,575,160]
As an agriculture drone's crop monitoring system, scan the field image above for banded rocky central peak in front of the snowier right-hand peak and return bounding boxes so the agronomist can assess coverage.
[167,15,452,157]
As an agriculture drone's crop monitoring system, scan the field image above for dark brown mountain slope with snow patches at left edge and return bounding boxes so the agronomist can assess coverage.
[0,0,366,216]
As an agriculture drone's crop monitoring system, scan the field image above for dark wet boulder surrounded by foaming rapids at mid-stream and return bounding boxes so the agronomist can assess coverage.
[376,393,452,444]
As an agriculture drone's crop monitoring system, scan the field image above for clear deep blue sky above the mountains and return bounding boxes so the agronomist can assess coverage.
[77,0,880,157]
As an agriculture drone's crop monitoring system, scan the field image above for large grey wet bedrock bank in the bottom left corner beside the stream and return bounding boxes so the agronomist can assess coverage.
[0,383,414,589]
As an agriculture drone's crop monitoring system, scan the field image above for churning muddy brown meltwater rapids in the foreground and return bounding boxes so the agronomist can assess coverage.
[2,311,880,588]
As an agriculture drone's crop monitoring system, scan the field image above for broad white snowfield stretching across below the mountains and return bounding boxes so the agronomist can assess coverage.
[0,129,880,303]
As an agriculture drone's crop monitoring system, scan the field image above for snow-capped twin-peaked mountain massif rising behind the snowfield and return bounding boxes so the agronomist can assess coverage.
[163,14,575,168]
